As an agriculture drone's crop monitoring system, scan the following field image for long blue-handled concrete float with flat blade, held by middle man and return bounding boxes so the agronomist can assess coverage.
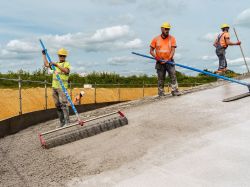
[132,52,250,102]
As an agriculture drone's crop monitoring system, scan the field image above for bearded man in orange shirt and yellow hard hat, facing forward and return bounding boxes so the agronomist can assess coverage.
[150,22,181,97]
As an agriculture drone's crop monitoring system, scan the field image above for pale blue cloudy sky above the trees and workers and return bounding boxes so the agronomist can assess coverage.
[0,0,250,75]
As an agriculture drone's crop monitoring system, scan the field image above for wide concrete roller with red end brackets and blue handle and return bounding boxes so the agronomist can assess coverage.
[39,40,128,148]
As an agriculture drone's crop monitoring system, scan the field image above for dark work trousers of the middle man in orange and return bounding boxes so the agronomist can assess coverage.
[155,62,178,96]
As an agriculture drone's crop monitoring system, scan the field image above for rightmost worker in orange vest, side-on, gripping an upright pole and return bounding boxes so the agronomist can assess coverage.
[214,24,241,73]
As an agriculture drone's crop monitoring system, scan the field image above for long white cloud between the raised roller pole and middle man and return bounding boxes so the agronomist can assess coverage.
[43,25,142,52]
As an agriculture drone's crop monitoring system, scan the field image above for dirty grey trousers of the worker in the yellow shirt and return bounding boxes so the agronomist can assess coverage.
[52,88,69,127]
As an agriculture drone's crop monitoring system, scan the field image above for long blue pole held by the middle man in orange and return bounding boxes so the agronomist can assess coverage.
[132,52,250,89]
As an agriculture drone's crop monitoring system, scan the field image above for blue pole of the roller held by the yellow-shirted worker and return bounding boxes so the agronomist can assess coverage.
[39,39,80,121]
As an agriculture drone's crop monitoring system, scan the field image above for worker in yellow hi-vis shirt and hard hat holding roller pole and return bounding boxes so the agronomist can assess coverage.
[42,48,70,127]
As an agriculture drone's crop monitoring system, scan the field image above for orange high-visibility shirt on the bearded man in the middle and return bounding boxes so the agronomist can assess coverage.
[150,35,177,60]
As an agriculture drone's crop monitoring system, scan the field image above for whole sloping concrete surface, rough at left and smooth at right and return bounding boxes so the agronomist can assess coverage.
[0,80,250,187]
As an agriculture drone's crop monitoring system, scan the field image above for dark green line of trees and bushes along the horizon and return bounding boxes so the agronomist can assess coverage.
[0,69,239,88]
